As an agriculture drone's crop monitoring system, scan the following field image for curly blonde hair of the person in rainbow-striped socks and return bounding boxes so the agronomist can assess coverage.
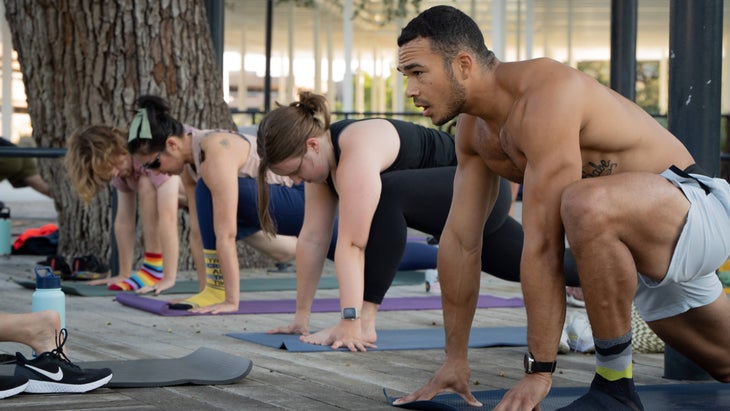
[64,125,129,204]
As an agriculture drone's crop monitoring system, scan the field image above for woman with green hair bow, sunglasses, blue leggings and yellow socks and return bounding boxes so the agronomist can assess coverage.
[127,96,304,314]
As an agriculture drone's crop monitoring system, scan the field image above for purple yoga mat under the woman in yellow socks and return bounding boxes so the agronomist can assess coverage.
[116,293,524,317]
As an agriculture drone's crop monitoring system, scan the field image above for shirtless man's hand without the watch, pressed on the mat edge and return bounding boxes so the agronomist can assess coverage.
[393,359,482,407]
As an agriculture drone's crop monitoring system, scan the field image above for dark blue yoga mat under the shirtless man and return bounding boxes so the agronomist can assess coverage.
[383,383,730,411]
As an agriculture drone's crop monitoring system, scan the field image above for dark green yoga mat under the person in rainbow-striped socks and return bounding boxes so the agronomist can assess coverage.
[14,271,425,297]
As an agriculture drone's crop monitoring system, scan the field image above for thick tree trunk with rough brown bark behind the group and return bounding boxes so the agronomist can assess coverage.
[4,0,271,269]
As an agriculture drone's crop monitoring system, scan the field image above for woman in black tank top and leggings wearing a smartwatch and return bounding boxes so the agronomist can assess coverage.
[258,92,577,351]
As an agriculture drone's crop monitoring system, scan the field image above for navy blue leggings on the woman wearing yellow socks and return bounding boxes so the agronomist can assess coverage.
[195,177,438,270]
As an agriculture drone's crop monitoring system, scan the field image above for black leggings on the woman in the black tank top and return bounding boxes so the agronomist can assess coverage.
[364,167,579,304]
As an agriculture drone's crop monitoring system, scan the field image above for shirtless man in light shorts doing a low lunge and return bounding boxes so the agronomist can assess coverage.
[397,6,730,410]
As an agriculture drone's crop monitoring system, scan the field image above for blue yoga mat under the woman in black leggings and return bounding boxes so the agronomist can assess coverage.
[226,327,527,352]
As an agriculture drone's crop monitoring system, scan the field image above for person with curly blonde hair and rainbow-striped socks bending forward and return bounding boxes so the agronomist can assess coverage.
[65,125,186,294]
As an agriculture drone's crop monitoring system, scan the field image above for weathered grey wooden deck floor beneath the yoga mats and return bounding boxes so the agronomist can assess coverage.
[0,199,677,411]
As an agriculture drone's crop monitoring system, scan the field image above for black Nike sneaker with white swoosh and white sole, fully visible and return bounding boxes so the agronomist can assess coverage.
[15,328,112,393]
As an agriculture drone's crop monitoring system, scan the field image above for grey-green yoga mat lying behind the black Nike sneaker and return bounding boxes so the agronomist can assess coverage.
[0,347,253,388]
